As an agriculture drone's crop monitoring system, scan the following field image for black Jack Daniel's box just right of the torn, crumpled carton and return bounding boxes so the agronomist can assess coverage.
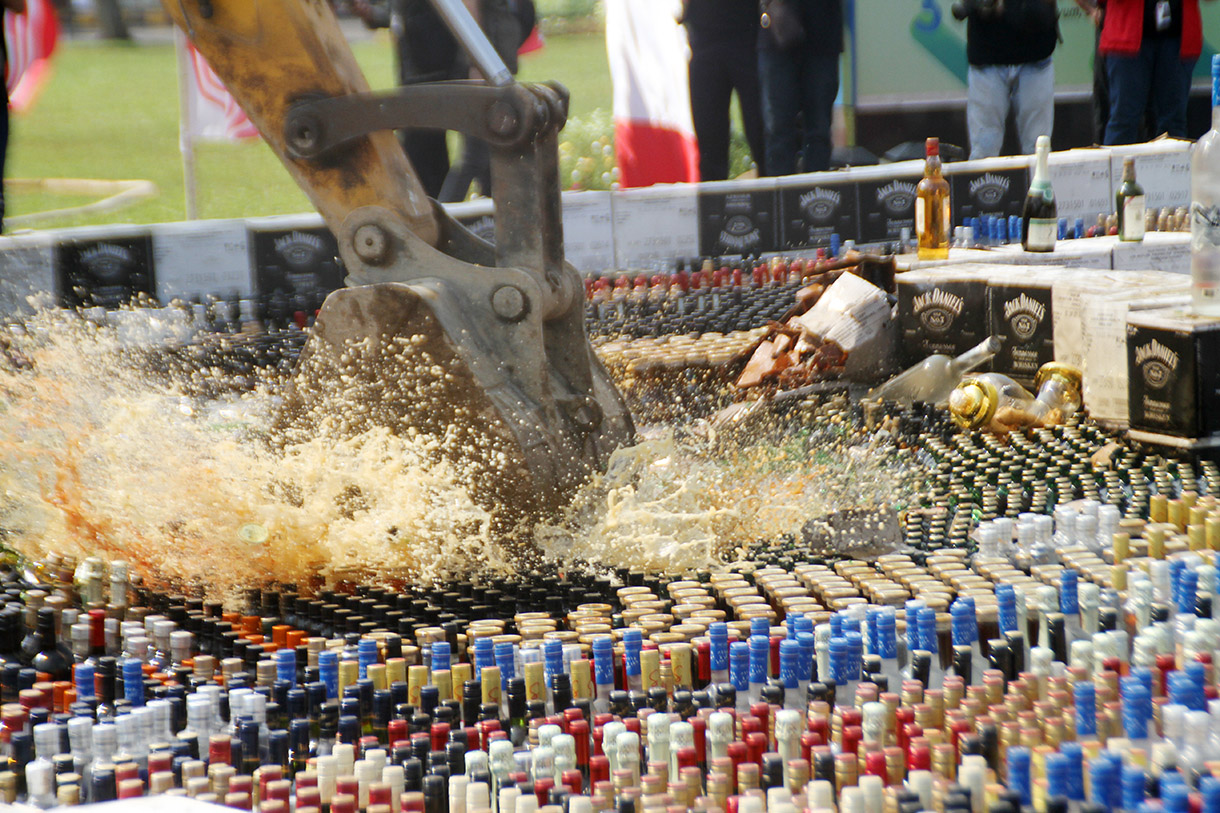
[895,265,989,366]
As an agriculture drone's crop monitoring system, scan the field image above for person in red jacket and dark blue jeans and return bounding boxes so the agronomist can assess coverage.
[1099,0,1203,145]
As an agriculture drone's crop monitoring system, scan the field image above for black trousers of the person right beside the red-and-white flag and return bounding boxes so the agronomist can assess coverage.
[691,32,766,181]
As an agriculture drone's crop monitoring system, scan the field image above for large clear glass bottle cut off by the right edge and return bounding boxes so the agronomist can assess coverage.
[1191,55,1220,316]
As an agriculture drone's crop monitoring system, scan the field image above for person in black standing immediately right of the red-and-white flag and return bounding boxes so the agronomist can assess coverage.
[682,0,766,181]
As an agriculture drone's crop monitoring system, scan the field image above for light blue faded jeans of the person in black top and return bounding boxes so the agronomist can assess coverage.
[966,57,1055,159]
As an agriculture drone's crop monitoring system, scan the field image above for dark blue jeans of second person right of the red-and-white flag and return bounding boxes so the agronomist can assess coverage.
[759,45,839,176]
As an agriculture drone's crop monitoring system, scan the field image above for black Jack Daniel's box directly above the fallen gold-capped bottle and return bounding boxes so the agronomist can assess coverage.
[987,265,1071,387]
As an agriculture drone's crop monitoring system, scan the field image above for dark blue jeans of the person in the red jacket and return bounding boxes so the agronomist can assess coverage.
[1105,37,1196,144]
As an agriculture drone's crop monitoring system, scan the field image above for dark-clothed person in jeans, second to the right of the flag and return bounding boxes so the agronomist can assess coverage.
[759,0,843,176]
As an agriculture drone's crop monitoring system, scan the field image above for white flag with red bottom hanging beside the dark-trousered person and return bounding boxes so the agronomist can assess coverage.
[605,0,699,187]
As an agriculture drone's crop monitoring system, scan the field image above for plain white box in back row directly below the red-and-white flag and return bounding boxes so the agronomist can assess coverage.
[611,184,699,269]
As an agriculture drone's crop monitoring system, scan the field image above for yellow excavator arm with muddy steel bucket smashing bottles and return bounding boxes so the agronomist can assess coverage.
[162,0,634,531]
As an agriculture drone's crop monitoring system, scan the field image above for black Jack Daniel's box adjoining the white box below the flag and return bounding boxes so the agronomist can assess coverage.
[699,178,778,256]
